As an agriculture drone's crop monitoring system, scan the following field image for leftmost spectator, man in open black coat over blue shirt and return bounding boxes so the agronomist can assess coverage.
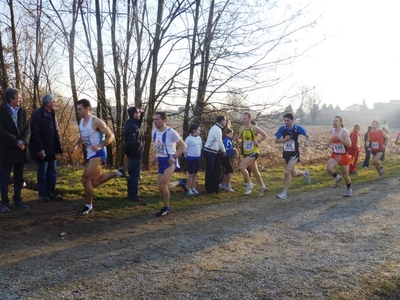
[0,88,31,213]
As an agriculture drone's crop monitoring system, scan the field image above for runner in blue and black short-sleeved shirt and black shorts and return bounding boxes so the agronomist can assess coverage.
[275,113,311,200]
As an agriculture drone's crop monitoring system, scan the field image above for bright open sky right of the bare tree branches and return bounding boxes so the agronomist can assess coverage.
[290,0,400,109]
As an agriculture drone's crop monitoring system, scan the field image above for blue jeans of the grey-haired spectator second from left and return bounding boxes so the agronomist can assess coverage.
[37,160,57,197]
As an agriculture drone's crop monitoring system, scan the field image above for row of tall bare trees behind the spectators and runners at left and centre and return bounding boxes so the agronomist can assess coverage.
[0,0,317,166]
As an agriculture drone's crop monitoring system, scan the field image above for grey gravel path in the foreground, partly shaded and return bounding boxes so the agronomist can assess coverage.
[0,178,400,299]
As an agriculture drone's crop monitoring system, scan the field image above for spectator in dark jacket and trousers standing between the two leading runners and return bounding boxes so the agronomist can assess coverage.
[124,107,143,201]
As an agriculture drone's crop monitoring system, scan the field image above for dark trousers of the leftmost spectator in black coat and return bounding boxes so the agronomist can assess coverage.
[0,163,24,205]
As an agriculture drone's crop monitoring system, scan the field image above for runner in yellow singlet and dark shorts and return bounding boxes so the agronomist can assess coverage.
[235,112,268,196]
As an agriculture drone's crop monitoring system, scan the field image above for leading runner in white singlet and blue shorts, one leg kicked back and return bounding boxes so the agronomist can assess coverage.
[69,99,128,216]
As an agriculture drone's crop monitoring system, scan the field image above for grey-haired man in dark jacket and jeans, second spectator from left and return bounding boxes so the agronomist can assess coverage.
[29,94,62,202]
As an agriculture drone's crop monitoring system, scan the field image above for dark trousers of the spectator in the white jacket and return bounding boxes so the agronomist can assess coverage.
[203,151,221,194]
